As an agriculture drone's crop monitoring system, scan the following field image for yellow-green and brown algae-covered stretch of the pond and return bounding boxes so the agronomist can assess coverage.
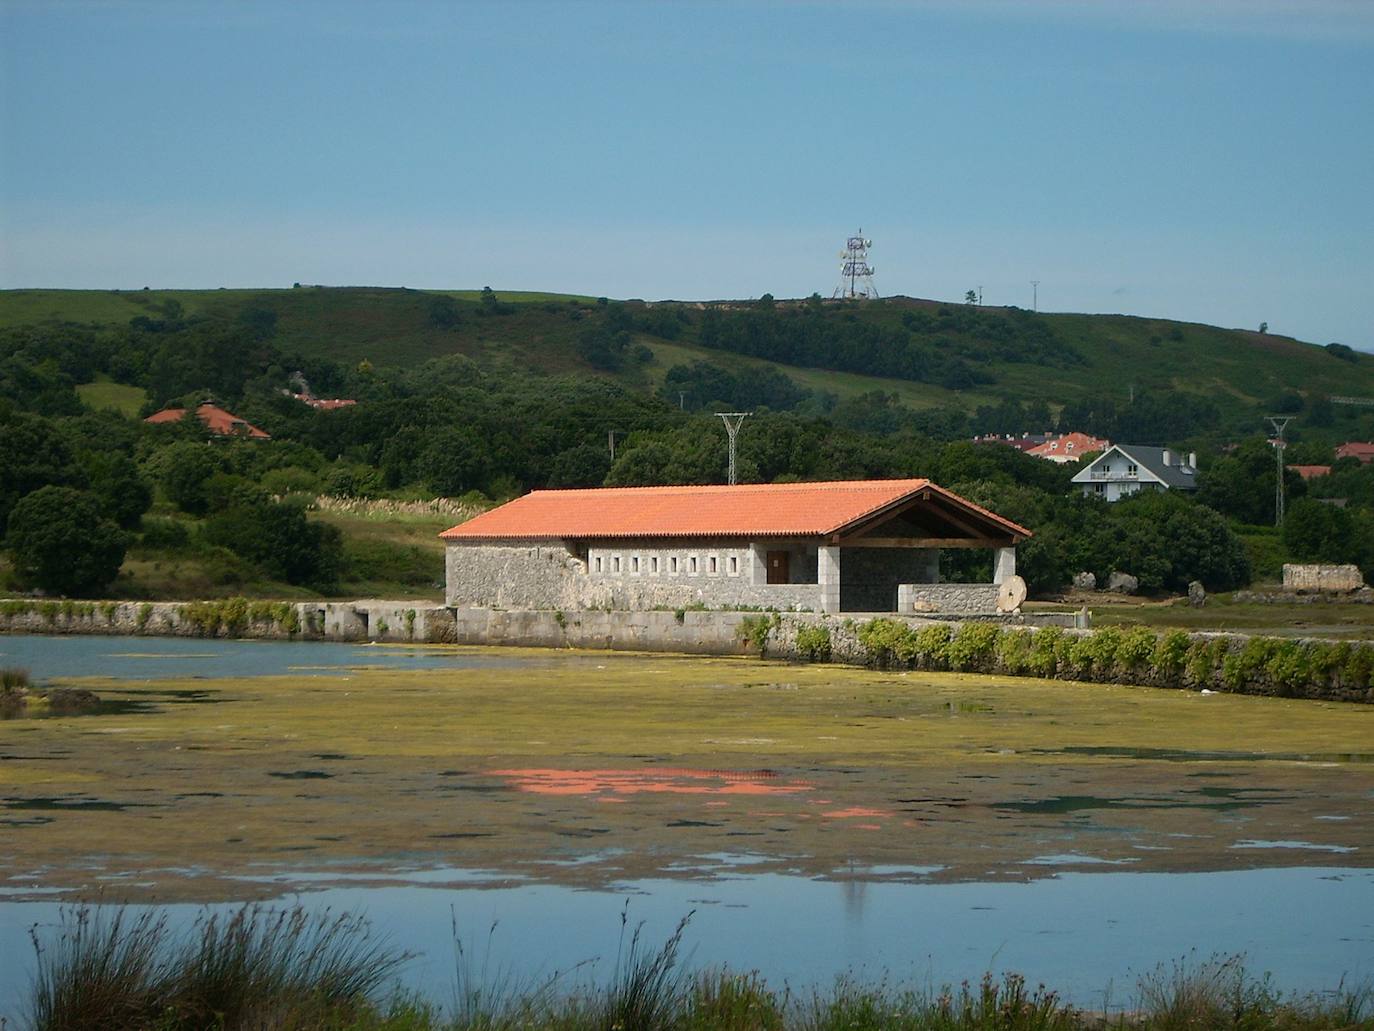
[0,649,1374,900]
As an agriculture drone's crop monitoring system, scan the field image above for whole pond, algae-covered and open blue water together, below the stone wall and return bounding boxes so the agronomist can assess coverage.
[0,636,1374,1017]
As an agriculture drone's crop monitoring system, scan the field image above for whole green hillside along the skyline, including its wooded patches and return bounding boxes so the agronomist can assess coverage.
[0,286,1374,429]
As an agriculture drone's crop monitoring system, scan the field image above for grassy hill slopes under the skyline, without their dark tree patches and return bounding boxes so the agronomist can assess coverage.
[0,286,1374,418]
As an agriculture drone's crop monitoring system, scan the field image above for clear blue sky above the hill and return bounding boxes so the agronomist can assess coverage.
[0,0,1374,349]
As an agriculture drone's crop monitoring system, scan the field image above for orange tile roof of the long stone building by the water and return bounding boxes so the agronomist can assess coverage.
[440,480,1031,540]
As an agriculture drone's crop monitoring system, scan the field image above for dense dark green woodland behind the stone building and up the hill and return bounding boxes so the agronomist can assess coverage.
[0,302,1374,594]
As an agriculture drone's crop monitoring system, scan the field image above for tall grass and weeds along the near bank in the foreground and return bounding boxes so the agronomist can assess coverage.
[21,906,1374,1031]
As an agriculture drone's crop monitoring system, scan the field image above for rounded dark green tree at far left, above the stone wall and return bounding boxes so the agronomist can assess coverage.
[5,487,128,594]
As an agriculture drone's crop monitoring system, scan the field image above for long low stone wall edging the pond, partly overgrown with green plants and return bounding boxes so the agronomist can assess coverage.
[0,598,1374,702]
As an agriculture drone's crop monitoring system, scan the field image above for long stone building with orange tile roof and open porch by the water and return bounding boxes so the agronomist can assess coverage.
[440,480,1031,613]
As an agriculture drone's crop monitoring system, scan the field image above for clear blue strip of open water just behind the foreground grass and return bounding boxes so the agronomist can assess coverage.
[0,866,1374,1016]
